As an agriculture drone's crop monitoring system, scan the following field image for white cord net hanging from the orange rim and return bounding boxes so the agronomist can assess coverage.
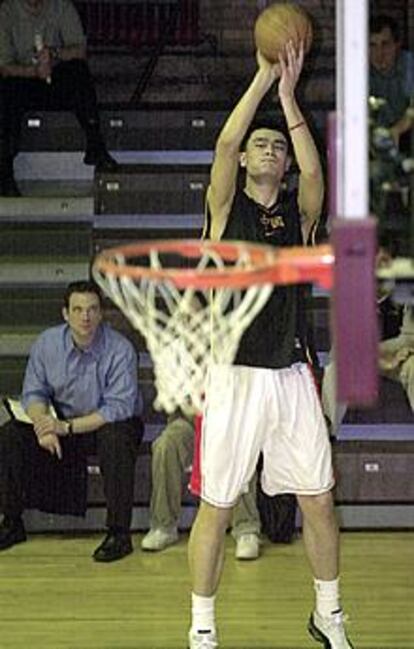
[94,240,273,412]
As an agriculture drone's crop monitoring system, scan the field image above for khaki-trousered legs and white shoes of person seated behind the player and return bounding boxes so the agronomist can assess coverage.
[141,412,260,560]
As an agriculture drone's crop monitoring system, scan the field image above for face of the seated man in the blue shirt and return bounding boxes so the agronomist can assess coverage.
[63,293,102,346]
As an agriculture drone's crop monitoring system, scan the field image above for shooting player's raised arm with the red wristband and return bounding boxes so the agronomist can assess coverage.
[279,43,324,242]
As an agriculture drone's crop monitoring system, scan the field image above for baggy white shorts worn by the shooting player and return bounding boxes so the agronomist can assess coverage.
[195,363,334,507]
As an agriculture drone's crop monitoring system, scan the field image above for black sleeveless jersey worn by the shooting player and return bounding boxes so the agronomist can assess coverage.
[210,191,306,369]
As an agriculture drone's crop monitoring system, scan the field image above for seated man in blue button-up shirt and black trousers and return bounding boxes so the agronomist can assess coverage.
[0,282,143,562]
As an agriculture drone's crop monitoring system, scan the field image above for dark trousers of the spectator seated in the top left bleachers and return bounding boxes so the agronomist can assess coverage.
[0,59,103,170]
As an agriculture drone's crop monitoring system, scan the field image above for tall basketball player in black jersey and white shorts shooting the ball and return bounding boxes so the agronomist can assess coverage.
[189,43,352,649]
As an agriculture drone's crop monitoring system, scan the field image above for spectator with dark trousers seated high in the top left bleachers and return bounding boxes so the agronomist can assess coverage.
[0,0,116,196]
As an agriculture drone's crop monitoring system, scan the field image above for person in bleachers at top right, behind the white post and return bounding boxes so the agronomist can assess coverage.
[369,15,414,150]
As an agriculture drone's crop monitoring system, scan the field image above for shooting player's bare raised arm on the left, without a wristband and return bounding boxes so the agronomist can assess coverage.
[207,52,279,239]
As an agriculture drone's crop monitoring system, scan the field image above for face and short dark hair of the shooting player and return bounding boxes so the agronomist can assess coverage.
[240,128,289,181]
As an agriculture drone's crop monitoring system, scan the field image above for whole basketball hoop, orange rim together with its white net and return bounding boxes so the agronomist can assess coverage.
[93,239,333,412]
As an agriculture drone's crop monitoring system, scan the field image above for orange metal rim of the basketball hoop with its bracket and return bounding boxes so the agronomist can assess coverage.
[94,239,334,289]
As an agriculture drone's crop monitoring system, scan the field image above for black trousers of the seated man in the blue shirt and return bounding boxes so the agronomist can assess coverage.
[0,418,144,530]
